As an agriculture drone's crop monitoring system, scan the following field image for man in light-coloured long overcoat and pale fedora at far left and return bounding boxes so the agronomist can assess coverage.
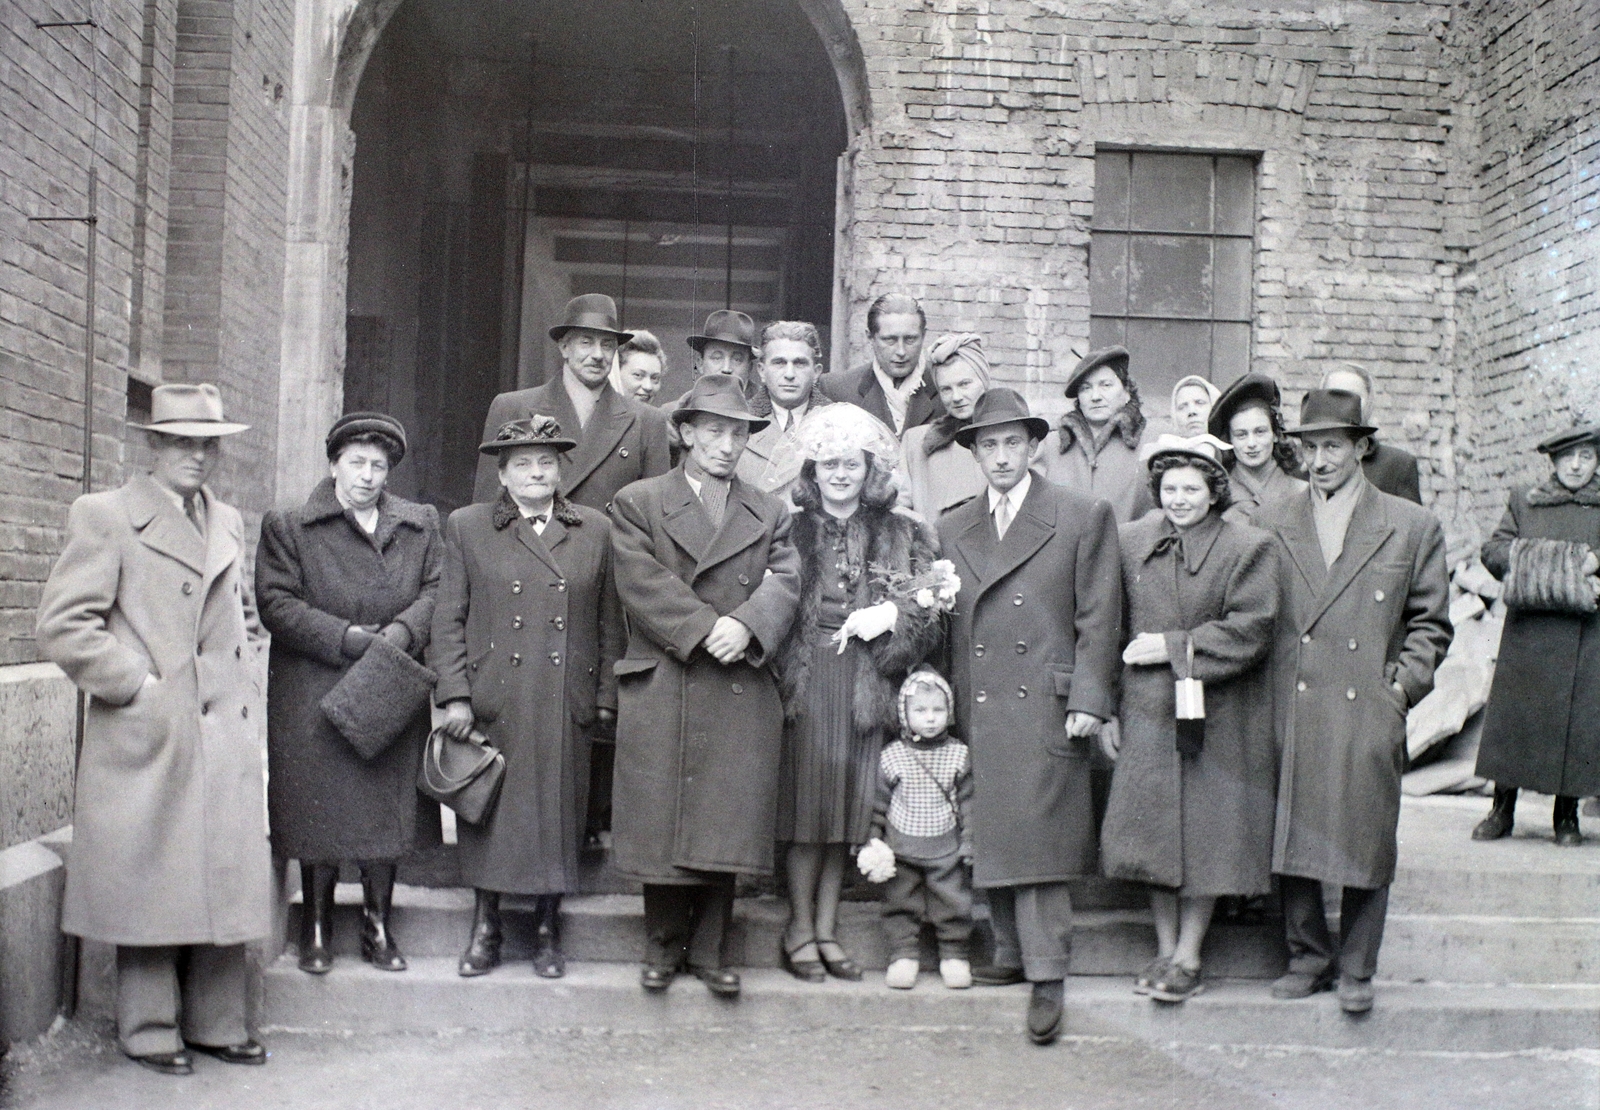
[37,384,272,1075]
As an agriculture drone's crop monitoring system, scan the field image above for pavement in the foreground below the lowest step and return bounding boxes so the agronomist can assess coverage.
[0,1022,1600,1110]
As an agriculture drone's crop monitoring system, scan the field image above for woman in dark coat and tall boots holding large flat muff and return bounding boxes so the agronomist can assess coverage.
[256,413,443,974]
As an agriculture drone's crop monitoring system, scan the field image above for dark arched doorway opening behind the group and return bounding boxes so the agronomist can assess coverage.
[344,0,861,509]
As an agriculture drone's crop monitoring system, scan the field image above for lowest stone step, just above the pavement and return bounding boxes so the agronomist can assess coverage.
[261,956,1600,1052]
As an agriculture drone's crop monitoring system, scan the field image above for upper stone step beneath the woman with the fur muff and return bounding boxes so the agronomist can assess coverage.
[1389,795,1600,920]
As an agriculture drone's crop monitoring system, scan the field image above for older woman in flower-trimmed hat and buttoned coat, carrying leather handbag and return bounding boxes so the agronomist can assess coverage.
[429,414,622,979]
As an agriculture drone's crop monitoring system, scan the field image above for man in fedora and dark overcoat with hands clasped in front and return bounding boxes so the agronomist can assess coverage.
[611,374,800,996]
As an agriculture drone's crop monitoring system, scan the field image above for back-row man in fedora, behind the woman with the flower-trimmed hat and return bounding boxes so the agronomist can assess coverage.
[472,293,670,512]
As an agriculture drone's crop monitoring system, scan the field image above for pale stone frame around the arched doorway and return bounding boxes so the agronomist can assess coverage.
[274,0,872,504]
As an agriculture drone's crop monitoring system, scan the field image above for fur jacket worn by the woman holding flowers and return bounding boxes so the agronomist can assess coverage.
[774,507,944,739]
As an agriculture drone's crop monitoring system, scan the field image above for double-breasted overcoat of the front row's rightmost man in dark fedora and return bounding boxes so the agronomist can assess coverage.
[1254,478,1451,889]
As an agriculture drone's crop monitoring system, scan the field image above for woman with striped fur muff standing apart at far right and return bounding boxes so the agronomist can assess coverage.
[1472,427,1600,846]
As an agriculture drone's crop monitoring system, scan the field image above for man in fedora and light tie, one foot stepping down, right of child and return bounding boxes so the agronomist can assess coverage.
[939,389,1122,1044]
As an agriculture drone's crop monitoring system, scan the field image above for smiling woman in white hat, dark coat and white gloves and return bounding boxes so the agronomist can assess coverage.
[1101,435,1278,1001]
